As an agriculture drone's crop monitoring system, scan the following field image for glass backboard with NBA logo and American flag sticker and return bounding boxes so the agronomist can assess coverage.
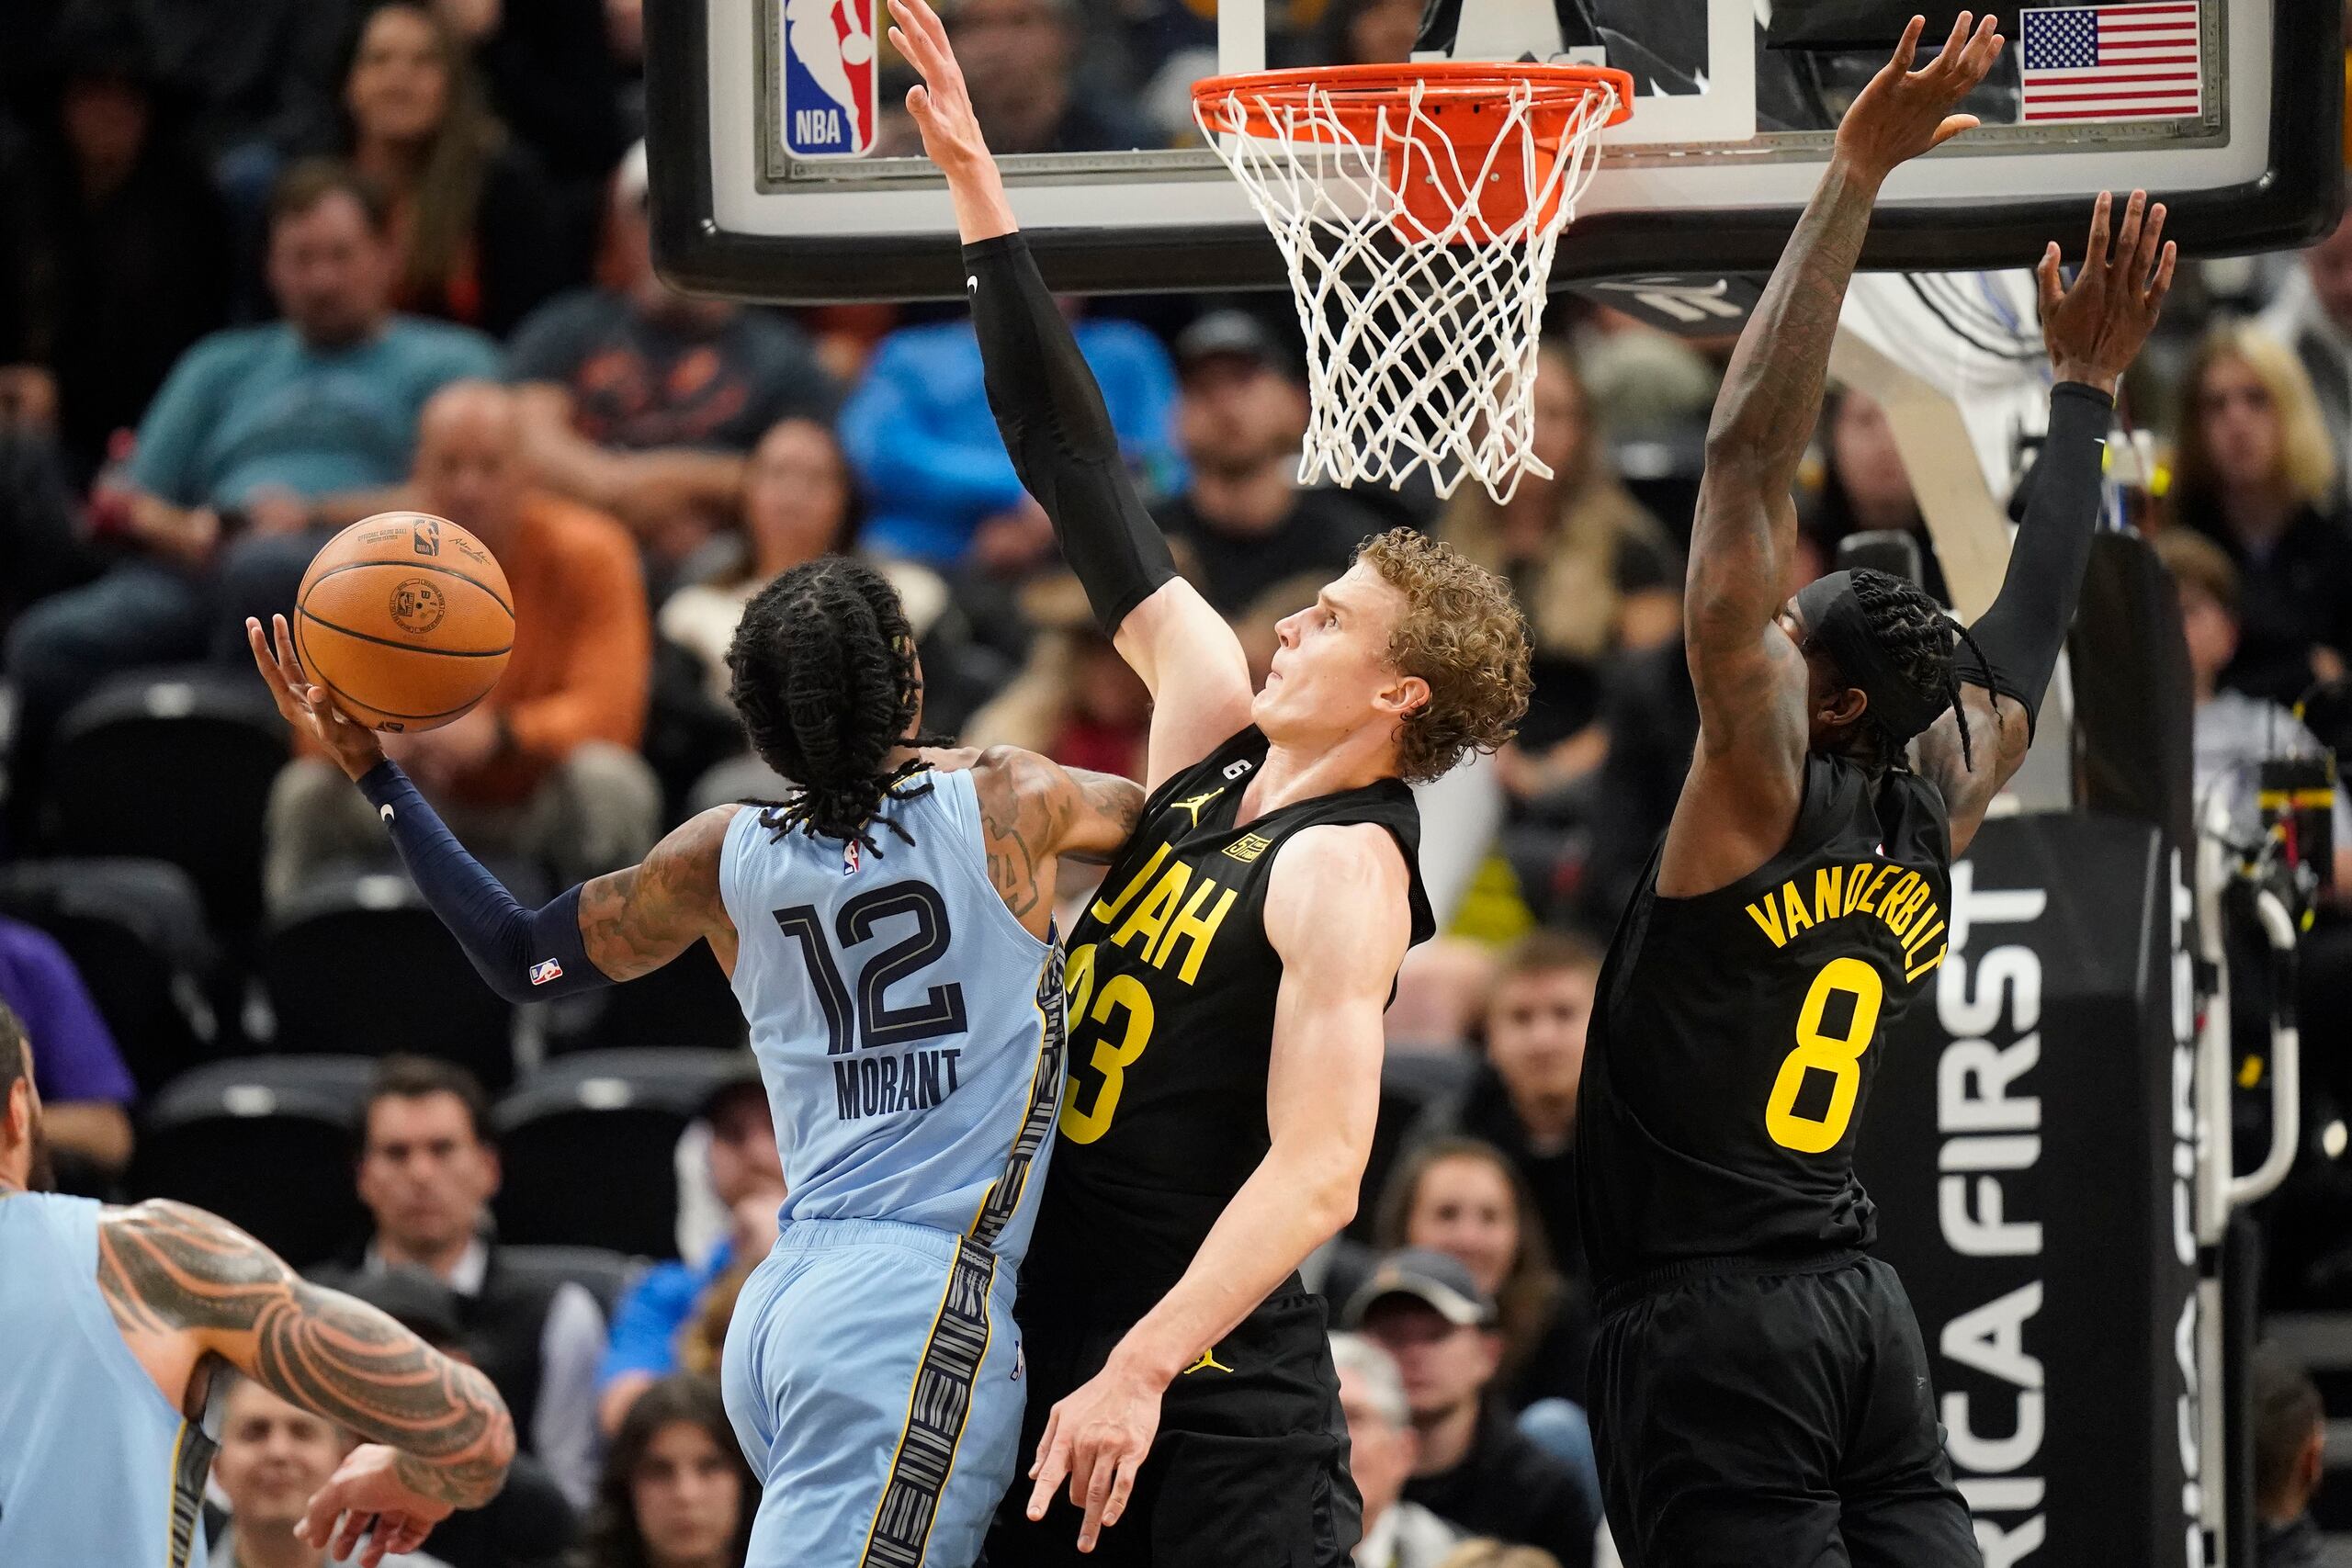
[647,0,2343,303]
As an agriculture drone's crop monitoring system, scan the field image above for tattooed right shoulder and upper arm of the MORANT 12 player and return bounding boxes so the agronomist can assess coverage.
[971,745,1143,938]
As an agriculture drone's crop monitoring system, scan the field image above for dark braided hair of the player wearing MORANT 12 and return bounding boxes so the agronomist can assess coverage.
[727,555,932,853]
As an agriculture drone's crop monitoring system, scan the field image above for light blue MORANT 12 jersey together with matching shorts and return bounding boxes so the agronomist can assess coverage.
[719,773,1063,1568]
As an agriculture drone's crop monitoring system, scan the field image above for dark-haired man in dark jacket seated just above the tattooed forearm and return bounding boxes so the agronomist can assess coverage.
[357,1055,605,1505]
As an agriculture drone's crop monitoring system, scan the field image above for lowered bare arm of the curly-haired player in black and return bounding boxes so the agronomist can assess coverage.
[1028,823,1414,1551]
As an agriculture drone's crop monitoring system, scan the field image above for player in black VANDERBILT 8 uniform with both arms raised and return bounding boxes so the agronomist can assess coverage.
[1576,12,2173,1568]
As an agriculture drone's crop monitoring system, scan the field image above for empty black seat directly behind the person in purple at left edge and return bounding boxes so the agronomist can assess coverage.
[0,861,219,1096]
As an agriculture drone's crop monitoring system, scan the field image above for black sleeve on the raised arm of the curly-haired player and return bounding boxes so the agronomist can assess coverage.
[965,232,1176,637]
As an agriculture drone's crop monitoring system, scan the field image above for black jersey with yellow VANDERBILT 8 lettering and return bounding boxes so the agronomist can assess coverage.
[1576,755,1952,1288]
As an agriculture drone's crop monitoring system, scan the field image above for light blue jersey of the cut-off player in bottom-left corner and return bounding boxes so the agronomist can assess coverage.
[0,1192,211,1568]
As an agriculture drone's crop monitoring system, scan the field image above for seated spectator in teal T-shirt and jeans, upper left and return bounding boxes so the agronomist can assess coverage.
[7,163,496,808]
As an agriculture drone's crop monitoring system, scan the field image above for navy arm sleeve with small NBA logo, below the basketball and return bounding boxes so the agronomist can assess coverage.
[360,761,614,1001]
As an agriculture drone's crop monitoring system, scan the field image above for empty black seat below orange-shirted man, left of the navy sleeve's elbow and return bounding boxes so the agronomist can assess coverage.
[256,872,515,1093]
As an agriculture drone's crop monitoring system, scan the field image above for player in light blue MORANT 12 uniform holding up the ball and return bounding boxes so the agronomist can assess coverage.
[249,558,1143,1568]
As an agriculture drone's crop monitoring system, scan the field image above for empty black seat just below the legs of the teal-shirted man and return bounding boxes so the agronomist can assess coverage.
[45,668,287,933]
